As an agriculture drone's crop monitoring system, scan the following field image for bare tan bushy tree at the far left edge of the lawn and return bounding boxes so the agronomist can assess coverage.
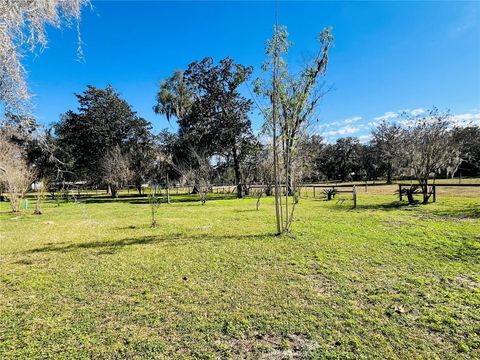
[0,137,34,213]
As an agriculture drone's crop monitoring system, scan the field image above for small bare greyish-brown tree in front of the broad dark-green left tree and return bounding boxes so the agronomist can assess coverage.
[100,147,130,198]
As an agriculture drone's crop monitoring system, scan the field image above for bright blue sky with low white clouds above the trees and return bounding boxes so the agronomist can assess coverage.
[25,1,480,141]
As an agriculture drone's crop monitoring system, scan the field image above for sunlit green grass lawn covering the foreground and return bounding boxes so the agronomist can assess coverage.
[0,193,480,359]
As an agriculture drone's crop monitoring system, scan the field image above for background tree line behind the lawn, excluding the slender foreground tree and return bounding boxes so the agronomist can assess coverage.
[0,79,480,208]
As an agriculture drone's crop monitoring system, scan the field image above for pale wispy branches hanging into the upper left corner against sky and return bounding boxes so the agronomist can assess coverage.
[0,0,89,112]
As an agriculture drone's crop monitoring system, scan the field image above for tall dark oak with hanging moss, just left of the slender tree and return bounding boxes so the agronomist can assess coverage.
[154,57,256,198]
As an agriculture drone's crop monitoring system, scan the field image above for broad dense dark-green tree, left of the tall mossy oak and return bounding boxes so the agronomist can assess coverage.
[55,85,150,194]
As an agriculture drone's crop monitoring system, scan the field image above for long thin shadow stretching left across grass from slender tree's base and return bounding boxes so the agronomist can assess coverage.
[23,233,275,254]
